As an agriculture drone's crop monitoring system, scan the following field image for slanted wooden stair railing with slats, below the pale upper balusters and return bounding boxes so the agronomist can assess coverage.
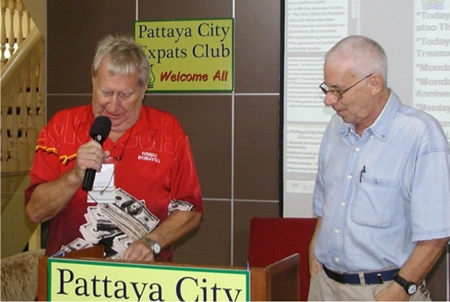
[1,27,45,172]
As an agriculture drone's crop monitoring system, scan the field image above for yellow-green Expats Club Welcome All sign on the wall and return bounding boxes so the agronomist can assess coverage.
[134,18,234,92]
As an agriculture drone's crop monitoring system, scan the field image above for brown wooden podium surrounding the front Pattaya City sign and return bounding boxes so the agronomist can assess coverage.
[37,246,300,301]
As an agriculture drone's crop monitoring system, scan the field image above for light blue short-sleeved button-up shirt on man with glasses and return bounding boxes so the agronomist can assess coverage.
[314,91,450,272]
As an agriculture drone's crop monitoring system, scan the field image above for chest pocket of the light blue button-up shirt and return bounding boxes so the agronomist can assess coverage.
[351,173,400,228]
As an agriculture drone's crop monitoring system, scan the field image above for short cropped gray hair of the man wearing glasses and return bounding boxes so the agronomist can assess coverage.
[325,35,388,85]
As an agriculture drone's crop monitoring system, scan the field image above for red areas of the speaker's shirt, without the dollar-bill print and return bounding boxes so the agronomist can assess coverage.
[25,105,203,261]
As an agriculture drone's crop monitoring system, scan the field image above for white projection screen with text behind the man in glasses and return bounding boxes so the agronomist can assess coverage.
[281,0,450,217]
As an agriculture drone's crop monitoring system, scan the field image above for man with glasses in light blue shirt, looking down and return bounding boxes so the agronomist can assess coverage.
[308,36,450,300]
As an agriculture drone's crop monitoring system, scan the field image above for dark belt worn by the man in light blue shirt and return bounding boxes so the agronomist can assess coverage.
[323,265,399,284]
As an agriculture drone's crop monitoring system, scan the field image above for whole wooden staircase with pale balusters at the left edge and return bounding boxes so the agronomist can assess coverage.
[0,0,46,258]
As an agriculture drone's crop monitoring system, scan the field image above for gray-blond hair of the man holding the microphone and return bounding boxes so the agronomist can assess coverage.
[91,35,150,87]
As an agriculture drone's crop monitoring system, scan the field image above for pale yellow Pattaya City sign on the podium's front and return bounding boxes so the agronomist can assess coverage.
[47,258,250,301]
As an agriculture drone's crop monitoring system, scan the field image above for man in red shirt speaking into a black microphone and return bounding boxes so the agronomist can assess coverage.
[25,36,203,261]
